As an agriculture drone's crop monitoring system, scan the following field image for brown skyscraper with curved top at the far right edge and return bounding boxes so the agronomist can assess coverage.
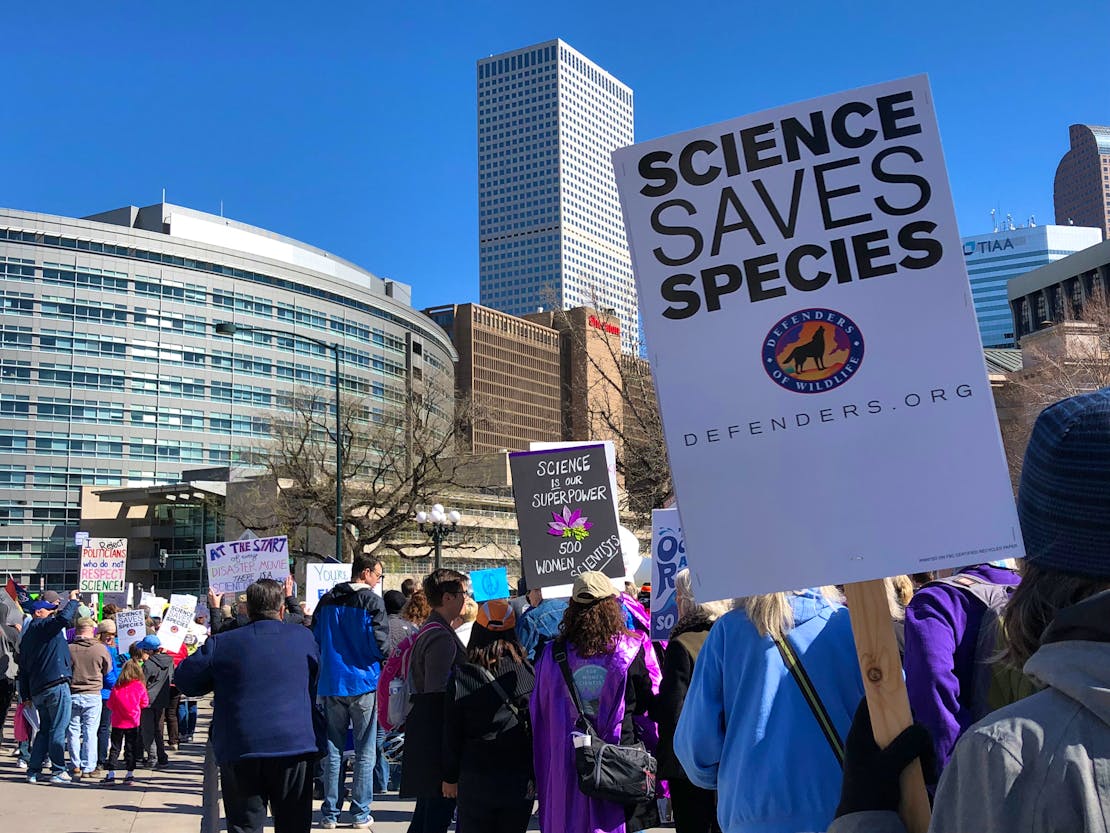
[1052,124,1110,239]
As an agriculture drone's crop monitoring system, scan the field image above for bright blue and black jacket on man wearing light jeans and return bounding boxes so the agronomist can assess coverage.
[312,582,390,697]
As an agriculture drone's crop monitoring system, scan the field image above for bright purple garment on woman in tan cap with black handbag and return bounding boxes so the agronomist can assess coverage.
[531,633,659,833]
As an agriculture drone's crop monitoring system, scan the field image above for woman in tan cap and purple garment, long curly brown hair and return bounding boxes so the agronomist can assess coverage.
[528,572,658,833]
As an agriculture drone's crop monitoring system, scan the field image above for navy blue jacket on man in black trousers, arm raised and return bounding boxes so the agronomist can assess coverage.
[175,619,324,763]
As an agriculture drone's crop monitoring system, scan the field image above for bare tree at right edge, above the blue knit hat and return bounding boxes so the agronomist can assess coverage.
[1000,292,1110,489]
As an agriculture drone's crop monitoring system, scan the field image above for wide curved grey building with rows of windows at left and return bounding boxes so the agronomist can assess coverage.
[0,202,456,588]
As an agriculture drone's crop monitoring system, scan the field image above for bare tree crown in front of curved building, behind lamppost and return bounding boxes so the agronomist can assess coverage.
[233,388,470,561]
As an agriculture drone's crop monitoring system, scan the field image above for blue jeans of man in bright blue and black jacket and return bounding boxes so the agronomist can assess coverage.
[320,691,377,822]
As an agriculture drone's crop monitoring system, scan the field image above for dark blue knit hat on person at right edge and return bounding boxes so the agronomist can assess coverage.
[1018,388,1110,579]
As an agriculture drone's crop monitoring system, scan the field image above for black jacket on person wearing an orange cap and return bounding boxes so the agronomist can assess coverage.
[443,660,536,805]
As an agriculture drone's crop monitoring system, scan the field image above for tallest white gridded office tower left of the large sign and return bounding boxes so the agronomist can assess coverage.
[477,40,639,350]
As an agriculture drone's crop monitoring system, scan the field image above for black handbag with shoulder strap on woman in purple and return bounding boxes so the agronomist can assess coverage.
[552,639,656,804]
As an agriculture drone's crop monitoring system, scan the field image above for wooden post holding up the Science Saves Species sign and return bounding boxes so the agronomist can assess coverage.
[844,579,930,833]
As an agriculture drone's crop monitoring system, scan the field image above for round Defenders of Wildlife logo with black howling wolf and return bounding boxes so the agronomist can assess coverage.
[763,309,864,393]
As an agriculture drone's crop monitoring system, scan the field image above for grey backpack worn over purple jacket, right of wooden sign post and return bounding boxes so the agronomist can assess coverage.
[929,573,1037,722]
